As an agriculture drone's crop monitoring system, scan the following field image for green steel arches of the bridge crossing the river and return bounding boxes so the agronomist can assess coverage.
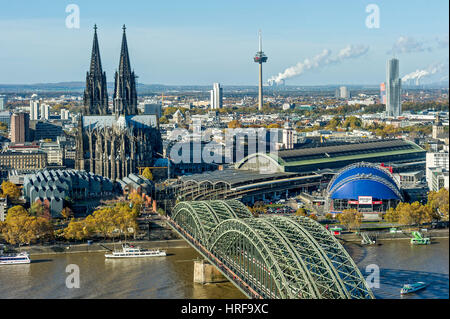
[172,200,374,299]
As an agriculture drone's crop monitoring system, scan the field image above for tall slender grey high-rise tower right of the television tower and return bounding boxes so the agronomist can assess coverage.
[386,59,402,116]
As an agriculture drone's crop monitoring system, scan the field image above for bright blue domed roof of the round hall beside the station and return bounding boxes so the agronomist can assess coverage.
[328,163,402,200]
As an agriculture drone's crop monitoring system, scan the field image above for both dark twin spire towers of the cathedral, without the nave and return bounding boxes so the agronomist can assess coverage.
[83,25,138,117]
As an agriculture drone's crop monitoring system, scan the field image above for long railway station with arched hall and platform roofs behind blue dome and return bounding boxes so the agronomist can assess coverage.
[173,139,426,204]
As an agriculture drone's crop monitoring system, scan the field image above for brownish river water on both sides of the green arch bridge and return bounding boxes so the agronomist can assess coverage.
[0,238,449,299]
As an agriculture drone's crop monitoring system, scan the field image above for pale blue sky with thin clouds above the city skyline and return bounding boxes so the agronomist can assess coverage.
[0,0,449,85]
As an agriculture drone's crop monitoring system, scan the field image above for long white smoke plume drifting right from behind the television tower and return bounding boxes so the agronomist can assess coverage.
[268,45,369,84]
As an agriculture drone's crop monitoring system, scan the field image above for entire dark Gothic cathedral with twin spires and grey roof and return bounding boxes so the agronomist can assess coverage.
[76,26,162,180]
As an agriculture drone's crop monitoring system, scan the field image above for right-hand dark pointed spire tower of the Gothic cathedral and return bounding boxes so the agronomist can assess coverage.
[113,25,138,117]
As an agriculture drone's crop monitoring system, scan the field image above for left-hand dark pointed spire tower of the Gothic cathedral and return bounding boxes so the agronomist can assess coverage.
[82,25,110,115]
